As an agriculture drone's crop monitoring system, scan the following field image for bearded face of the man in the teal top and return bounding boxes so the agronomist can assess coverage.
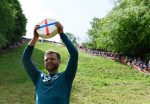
[44,53,60,74]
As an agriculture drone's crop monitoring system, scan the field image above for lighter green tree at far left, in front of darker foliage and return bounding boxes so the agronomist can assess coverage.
[0,0,15,47]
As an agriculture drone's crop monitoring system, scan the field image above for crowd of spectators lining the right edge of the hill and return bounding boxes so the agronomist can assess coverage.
[80,47,150,74]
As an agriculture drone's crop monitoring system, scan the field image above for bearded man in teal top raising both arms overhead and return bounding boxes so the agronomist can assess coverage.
[22,22,78,104]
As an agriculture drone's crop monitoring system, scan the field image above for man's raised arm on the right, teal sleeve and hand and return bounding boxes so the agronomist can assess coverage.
[56,23,78,86]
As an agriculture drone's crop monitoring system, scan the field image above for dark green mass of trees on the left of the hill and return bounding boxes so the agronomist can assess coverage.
[0,0,27,48]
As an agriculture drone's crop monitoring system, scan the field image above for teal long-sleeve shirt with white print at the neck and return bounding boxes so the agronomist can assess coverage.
[22,33,78,104]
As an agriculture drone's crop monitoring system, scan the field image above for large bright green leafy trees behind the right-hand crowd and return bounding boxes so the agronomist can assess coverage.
[86,0,150,58]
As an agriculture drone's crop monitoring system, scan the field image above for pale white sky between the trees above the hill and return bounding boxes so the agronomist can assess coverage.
[19,0,113,42]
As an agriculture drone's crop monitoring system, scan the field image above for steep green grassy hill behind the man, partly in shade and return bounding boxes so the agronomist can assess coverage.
[0,42,150,104]
